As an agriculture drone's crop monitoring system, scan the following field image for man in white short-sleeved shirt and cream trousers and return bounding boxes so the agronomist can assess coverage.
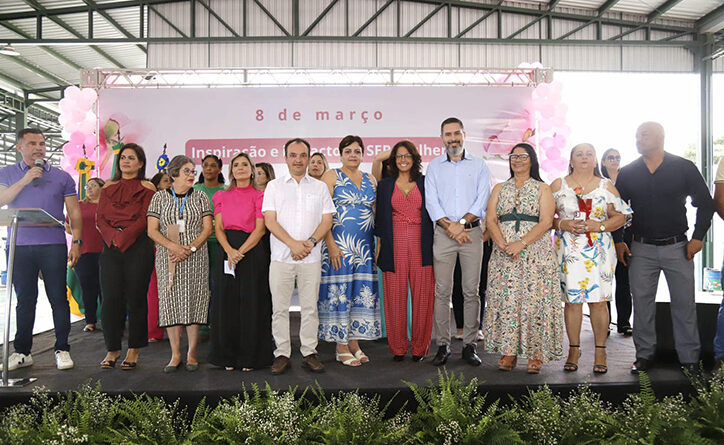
[261,139,335,374]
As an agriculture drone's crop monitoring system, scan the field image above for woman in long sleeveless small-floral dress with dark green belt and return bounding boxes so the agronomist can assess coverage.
[483,143,563,374]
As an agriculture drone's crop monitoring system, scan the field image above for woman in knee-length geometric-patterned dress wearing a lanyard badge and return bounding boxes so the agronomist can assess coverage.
[148,156,213,373]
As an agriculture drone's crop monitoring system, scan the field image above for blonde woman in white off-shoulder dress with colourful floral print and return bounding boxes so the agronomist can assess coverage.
[551,144,632,374]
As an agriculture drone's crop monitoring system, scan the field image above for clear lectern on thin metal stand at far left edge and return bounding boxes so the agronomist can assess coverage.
[0,209,63,388]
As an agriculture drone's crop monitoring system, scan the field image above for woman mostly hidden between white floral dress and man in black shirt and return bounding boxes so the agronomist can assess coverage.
[601,148,633,337]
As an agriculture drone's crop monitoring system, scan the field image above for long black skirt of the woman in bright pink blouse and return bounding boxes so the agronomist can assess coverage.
[209,230,274,369]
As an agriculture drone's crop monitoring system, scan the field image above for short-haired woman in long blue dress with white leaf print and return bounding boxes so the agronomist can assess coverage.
[318,136,380,366]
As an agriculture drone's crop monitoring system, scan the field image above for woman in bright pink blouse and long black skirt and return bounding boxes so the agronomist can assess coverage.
[209,153,274,371]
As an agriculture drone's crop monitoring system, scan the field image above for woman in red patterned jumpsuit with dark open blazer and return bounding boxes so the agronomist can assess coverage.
[375,141,435,362]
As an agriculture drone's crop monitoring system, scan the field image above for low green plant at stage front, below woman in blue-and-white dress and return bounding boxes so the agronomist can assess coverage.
[308,387,410,444]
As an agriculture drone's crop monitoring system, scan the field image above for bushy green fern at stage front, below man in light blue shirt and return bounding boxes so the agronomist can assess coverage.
[407,370,522,445]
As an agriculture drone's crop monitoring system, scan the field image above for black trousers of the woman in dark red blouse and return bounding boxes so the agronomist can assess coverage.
[100,234,153,351]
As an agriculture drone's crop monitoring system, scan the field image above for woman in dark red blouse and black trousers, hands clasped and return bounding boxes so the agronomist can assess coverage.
[96,143,156,370]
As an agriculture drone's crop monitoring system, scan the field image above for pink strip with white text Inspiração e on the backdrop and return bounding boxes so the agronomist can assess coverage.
[186,137,445,165]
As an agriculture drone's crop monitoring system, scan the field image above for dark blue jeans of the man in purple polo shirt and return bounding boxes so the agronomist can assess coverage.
[13,244,70,355]
